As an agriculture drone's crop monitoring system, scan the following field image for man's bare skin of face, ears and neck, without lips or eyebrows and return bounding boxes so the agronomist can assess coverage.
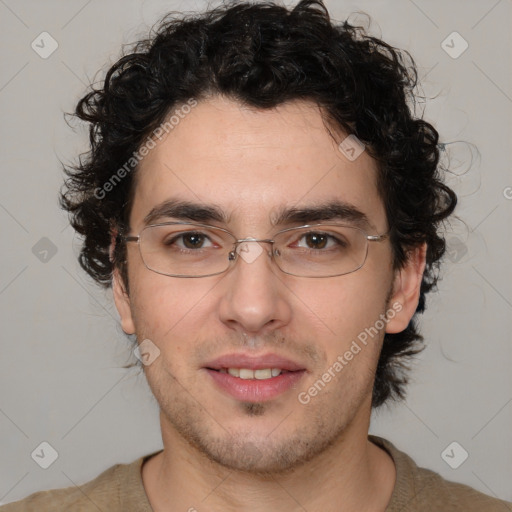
[113,97,425,512]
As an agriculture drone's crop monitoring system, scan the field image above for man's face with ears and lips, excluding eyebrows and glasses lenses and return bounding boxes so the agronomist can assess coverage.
[114,98,423,473]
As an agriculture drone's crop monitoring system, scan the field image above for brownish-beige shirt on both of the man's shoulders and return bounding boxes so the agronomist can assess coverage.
[0,435,512,512]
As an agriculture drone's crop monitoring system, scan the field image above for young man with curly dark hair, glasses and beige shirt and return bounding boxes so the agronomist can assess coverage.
[2,0,512,512]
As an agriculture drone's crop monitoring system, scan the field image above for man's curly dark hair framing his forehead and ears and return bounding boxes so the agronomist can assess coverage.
[60,0,457,408]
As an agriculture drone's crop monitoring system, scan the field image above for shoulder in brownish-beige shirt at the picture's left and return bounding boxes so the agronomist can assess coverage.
[0,455,158,512]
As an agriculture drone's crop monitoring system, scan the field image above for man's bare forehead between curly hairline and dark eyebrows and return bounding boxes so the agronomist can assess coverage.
[130,97,387,230]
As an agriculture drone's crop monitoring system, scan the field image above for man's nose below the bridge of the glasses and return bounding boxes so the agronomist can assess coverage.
[219,241,292,334]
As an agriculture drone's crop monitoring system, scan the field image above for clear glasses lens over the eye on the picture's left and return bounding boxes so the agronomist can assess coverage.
[140,224,235,277]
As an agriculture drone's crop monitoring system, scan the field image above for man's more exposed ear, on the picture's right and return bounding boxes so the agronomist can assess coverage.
[386,243,427,333]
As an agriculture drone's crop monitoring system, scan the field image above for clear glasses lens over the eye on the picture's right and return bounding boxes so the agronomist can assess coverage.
[274,224,368,277]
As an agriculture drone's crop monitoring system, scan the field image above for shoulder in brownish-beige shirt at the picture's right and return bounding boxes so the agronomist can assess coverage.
[369,435,512,512]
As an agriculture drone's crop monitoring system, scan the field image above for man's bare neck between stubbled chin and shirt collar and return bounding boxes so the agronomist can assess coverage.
[142,404,396,512]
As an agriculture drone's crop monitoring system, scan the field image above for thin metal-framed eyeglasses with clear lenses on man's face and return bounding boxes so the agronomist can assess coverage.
[122,222,388,277]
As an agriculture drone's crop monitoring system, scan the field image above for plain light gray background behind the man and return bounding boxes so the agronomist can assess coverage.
[0,0,512,503]
